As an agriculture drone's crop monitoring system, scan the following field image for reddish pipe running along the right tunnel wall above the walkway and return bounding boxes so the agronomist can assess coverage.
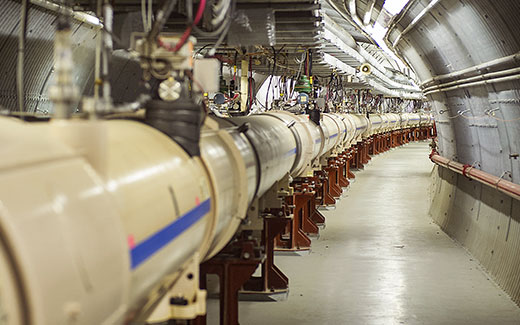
[430,152,520,200]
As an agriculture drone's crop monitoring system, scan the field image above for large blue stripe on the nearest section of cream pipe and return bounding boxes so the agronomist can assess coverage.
[130,199,211,270]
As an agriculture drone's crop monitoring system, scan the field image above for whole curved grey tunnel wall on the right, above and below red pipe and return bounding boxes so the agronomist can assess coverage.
[390,0,520,303]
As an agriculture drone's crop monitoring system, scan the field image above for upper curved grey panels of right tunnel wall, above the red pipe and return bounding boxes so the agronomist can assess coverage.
[390,0,520,183]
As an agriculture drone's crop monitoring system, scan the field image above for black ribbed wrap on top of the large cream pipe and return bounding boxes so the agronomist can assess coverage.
[145,97,204,157]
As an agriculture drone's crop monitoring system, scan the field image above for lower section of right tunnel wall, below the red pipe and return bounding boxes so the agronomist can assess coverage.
[430,167,520,304]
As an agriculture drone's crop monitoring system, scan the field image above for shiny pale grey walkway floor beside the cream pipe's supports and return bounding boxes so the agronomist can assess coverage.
[208,143,520,325]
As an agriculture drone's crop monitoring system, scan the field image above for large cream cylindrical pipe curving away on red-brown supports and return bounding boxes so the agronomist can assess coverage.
[0,112,432,325]
